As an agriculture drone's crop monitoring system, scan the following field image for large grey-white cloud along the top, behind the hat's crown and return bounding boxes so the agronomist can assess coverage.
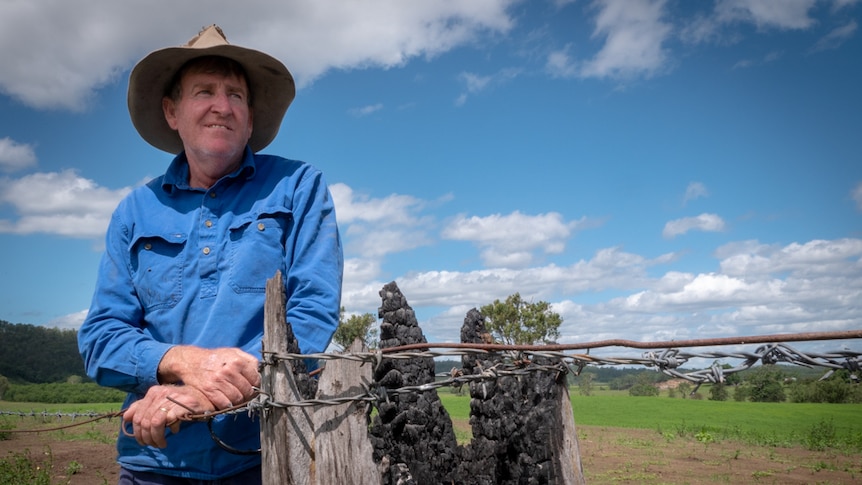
[0,0,514,110]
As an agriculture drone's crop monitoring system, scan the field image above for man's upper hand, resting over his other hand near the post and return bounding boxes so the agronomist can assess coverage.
[159,345,260,409]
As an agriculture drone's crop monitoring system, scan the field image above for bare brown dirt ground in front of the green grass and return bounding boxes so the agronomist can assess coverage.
[0,420,862,485]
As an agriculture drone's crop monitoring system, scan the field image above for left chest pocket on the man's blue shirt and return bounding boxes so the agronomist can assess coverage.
[129,233,188,310]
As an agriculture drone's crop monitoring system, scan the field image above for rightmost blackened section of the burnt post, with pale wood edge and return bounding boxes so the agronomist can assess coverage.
[459,308,585,485]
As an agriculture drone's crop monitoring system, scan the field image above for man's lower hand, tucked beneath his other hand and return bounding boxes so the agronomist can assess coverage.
[123,386,215,448]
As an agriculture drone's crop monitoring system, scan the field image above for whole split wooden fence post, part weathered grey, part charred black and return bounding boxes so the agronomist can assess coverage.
[260,273,584,485]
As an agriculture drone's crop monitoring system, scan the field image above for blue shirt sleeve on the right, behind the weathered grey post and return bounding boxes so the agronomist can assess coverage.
[285,170,344,353]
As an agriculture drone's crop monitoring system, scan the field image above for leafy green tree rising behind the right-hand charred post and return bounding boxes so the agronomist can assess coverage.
[479,293,563,345]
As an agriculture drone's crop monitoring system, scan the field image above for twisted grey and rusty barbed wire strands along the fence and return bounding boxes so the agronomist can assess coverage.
[0,330,862,432]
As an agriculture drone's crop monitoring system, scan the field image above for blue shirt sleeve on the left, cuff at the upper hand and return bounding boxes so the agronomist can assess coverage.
[78,208,172,394]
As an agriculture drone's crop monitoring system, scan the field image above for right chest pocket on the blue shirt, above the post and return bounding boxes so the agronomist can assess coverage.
[228,207,293,293]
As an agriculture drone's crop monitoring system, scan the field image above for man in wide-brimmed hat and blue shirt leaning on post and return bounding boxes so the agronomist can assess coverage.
[78,26,343,484]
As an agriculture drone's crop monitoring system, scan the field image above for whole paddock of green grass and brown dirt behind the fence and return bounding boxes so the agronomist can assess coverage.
[0,396,862,485]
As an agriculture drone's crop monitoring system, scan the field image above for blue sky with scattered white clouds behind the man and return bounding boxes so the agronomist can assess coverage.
[0,0,862,356]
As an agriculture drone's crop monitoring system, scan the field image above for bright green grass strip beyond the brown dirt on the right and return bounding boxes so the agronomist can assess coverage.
[438,388,862,451]
